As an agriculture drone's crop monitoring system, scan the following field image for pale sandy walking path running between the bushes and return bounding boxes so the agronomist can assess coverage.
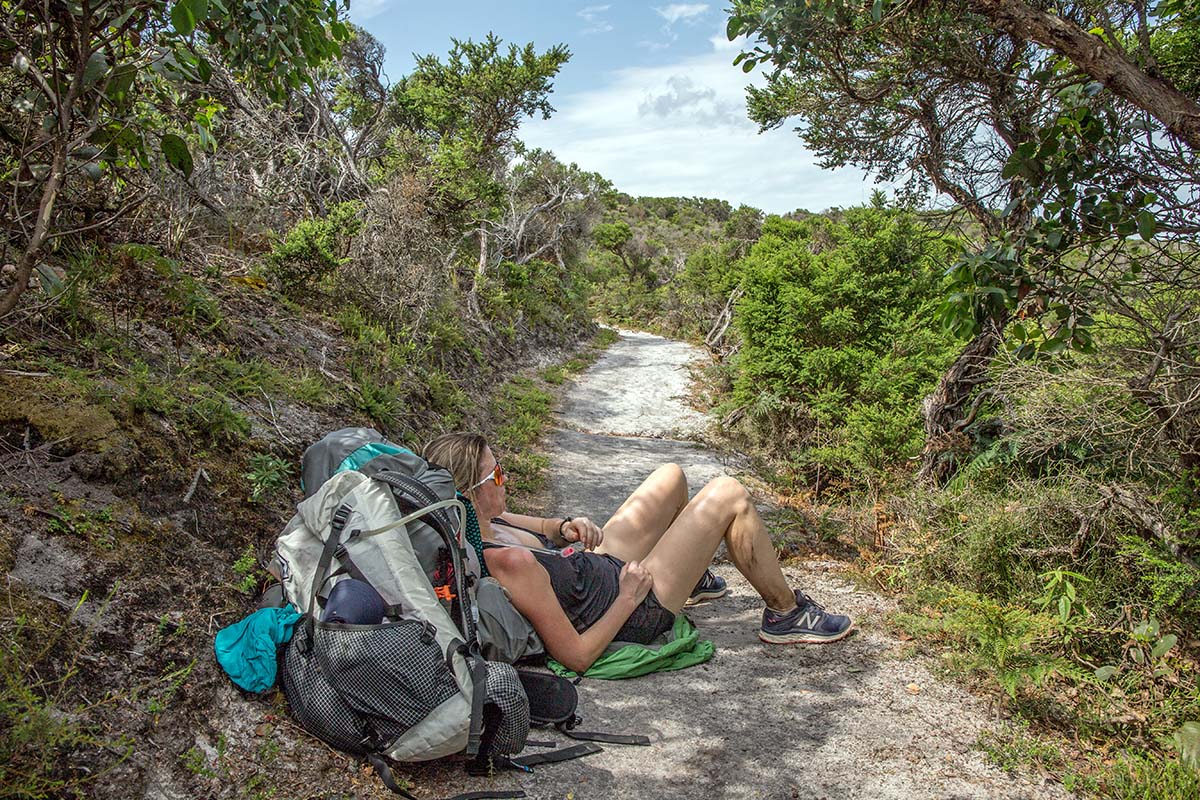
[412,332,1067,800]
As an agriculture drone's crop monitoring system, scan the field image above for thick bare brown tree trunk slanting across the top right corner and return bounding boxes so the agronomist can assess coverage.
[968,0,1200,151]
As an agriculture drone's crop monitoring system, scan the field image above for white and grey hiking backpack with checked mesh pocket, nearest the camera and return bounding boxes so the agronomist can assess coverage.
[276,462,529,790]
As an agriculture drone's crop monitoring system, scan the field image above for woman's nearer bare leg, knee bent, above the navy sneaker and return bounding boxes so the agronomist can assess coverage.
[638,476,796,613]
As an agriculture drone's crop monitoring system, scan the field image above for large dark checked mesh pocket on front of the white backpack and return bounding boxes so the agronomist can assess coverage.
[282,620,458,753]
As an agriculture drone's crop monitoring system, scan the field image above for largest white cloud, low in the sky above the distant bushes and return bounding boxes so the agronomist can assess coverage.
[521,37,875,213]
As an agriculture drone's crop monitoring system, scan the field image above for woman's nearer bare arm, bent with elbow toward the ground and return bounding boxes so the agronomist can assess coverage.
[484,548,653,674]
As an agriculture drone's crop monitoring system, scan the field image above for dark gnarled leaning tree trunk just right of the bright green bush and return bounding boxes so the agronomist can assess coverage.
[917,319,1003,485]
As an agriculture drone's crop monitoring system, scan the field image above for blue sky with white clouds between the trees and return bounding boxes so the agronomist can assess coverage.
[350,0,875,213]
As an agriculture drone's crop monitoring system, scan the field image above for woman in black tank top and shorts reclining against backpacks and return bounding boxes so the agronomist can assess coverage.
[424,433,854,674]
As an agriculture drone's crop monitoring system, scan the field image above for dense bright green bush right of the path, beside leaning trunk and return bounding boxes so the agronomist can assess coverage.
[725,209,954,488]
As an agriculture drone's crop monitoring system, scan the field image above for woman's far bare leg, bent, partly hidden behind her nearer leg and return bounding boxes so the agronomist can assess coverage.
[596,464,695,563]
